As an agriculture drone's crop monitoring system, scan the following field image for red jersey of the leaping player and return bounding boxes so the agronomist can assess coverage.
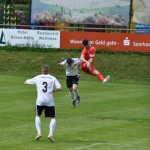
[81,47,96,64]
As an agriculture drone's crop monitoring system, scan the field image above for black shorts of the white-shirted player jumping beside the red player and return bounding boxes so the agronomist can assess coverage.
[66,75,80,88]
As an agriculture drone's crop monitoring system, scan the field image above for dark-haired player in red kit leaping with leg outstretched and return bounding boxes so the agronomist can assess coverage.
[80,39,110,83]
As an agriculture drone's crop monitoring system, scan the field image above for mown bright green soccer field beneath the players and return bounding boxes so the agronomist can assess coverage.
[0,75,150,150]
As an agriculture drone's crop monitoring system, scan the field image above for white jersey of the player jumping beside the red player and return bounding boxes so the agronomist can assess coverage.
[60,58,81,76]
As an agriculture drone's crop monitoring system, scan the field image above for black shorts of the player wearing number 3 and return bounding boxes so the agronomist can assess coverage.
[36,105,56,118]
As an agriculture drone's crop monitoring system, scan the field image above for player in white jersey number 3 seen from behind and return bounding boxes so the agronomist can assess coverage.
[24,64,61,143]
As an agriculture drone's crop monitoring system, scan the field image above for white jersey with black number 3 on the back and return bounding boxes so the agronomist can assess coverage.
[26,74,61,106]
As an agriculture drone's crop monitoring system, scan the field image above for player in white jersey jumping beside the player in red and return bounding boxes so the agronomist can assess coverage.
[58,58,81,108]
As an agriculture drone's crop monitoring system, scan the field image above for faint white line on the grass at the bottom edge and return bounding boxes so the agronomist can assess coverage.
[69,143,130,150]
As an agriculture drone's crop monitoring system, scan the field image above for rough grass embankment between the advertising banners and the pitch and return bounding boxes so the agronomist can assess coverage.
[0,47,150,82]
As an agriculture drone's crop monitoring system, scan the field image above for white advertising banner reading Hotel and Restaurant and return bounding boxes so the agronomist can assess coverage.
[0,29,60,48]
